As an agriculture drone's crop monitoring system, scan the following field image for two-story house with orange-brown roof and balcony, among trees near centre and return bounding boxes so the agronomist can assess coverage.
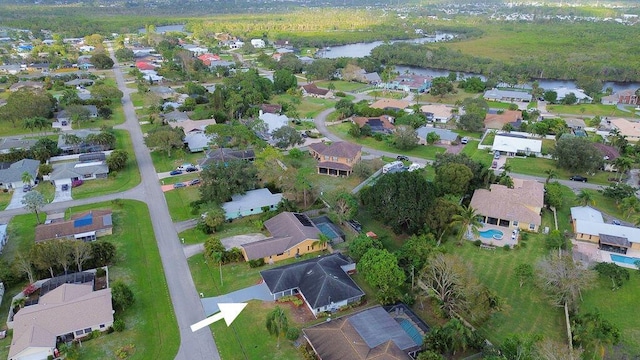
[309,141,362,176]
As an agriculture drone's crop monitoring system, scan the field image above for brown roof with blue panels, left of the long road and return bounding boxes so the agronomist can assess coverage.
[35,210,113,242]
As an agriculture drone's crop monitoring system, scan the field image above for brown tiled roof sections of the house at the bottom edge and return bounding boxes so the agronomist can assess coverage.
[303,307,411,360]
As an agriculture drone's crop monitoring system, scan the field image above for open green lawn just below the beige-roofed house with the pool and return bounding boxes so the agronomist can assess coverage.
[446,235,566,344]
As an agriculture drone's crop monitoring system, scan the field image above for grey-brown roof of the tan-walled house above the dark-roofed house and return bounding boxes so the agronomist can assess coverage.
[242,211,320,260]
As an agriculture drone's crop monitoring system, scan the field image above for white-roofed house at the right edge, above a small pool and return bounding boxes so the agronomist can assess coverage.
[571,206,640,254]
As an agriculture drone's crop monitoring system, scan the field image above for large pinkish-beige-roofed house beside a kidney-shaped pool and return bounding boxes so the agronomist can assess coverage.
[469,179,544,231]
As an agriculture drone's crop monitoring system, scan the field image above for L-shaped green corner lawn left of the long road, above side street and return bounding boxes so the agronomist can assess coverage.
[71,130,140,199]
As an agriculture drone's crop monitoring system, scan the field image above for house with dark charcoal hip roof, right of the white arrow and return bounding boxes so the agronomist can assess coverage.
[260,253,364,316]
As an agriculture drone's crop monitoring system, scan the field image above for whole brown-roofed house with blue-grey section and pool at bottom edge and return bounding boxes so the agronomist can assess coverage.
[302,304,429,360]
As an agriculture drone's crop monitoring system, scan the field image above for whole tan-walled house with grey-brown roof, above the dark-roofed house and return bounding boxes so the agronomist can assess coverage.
[241,211,328,264]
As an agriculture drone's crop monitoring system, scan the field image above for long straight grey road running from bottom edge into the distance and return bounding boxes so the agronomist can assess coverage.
[109,47,220,360]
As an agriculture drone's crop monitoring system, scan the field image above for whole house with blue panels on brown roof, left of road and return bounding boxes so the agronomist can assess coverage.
[35,210,113,243]
